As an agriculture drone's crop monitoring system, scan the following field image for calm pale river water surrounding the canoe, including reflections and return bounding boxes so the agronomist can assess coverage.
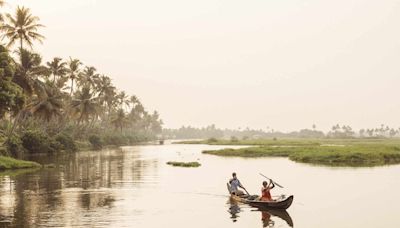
[0,144,400,228]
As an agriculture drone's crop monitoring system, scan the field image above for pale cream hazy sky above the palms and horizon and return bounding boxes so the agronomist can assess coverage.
[6,0,400,131]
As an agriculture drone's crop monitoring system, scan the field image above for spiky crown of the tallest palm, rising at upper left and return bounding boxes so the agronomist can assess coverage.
[0,6,45,49]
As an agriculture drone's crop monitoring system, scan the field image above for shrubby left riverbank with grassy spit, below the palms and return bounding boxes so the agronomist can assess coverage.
[0,131,154,172]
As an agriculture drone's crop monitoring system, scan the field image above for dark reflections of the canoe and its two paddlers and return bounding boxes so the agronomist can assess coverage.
[228,199,293,228]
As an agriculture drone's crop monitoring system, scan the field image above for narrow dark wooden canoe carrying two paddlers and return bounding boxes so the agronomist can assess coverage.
[227,183,293,210]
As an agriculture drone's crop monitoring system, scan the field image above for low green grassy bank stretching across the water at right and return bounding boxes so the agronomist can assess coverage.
[203,139,400,167]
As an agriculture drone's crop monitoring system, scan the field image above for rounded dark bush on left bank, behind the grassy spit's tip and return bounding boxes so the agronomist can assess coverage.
[21,130,52,153]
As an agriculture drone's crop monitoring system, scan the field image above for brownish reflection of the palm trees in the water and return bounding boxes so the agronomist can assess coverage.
[0,147,157,227]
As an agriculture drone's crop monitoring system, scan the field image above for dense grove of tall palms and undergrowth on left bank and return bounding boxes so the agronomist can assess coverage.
[0,4,162,156]
